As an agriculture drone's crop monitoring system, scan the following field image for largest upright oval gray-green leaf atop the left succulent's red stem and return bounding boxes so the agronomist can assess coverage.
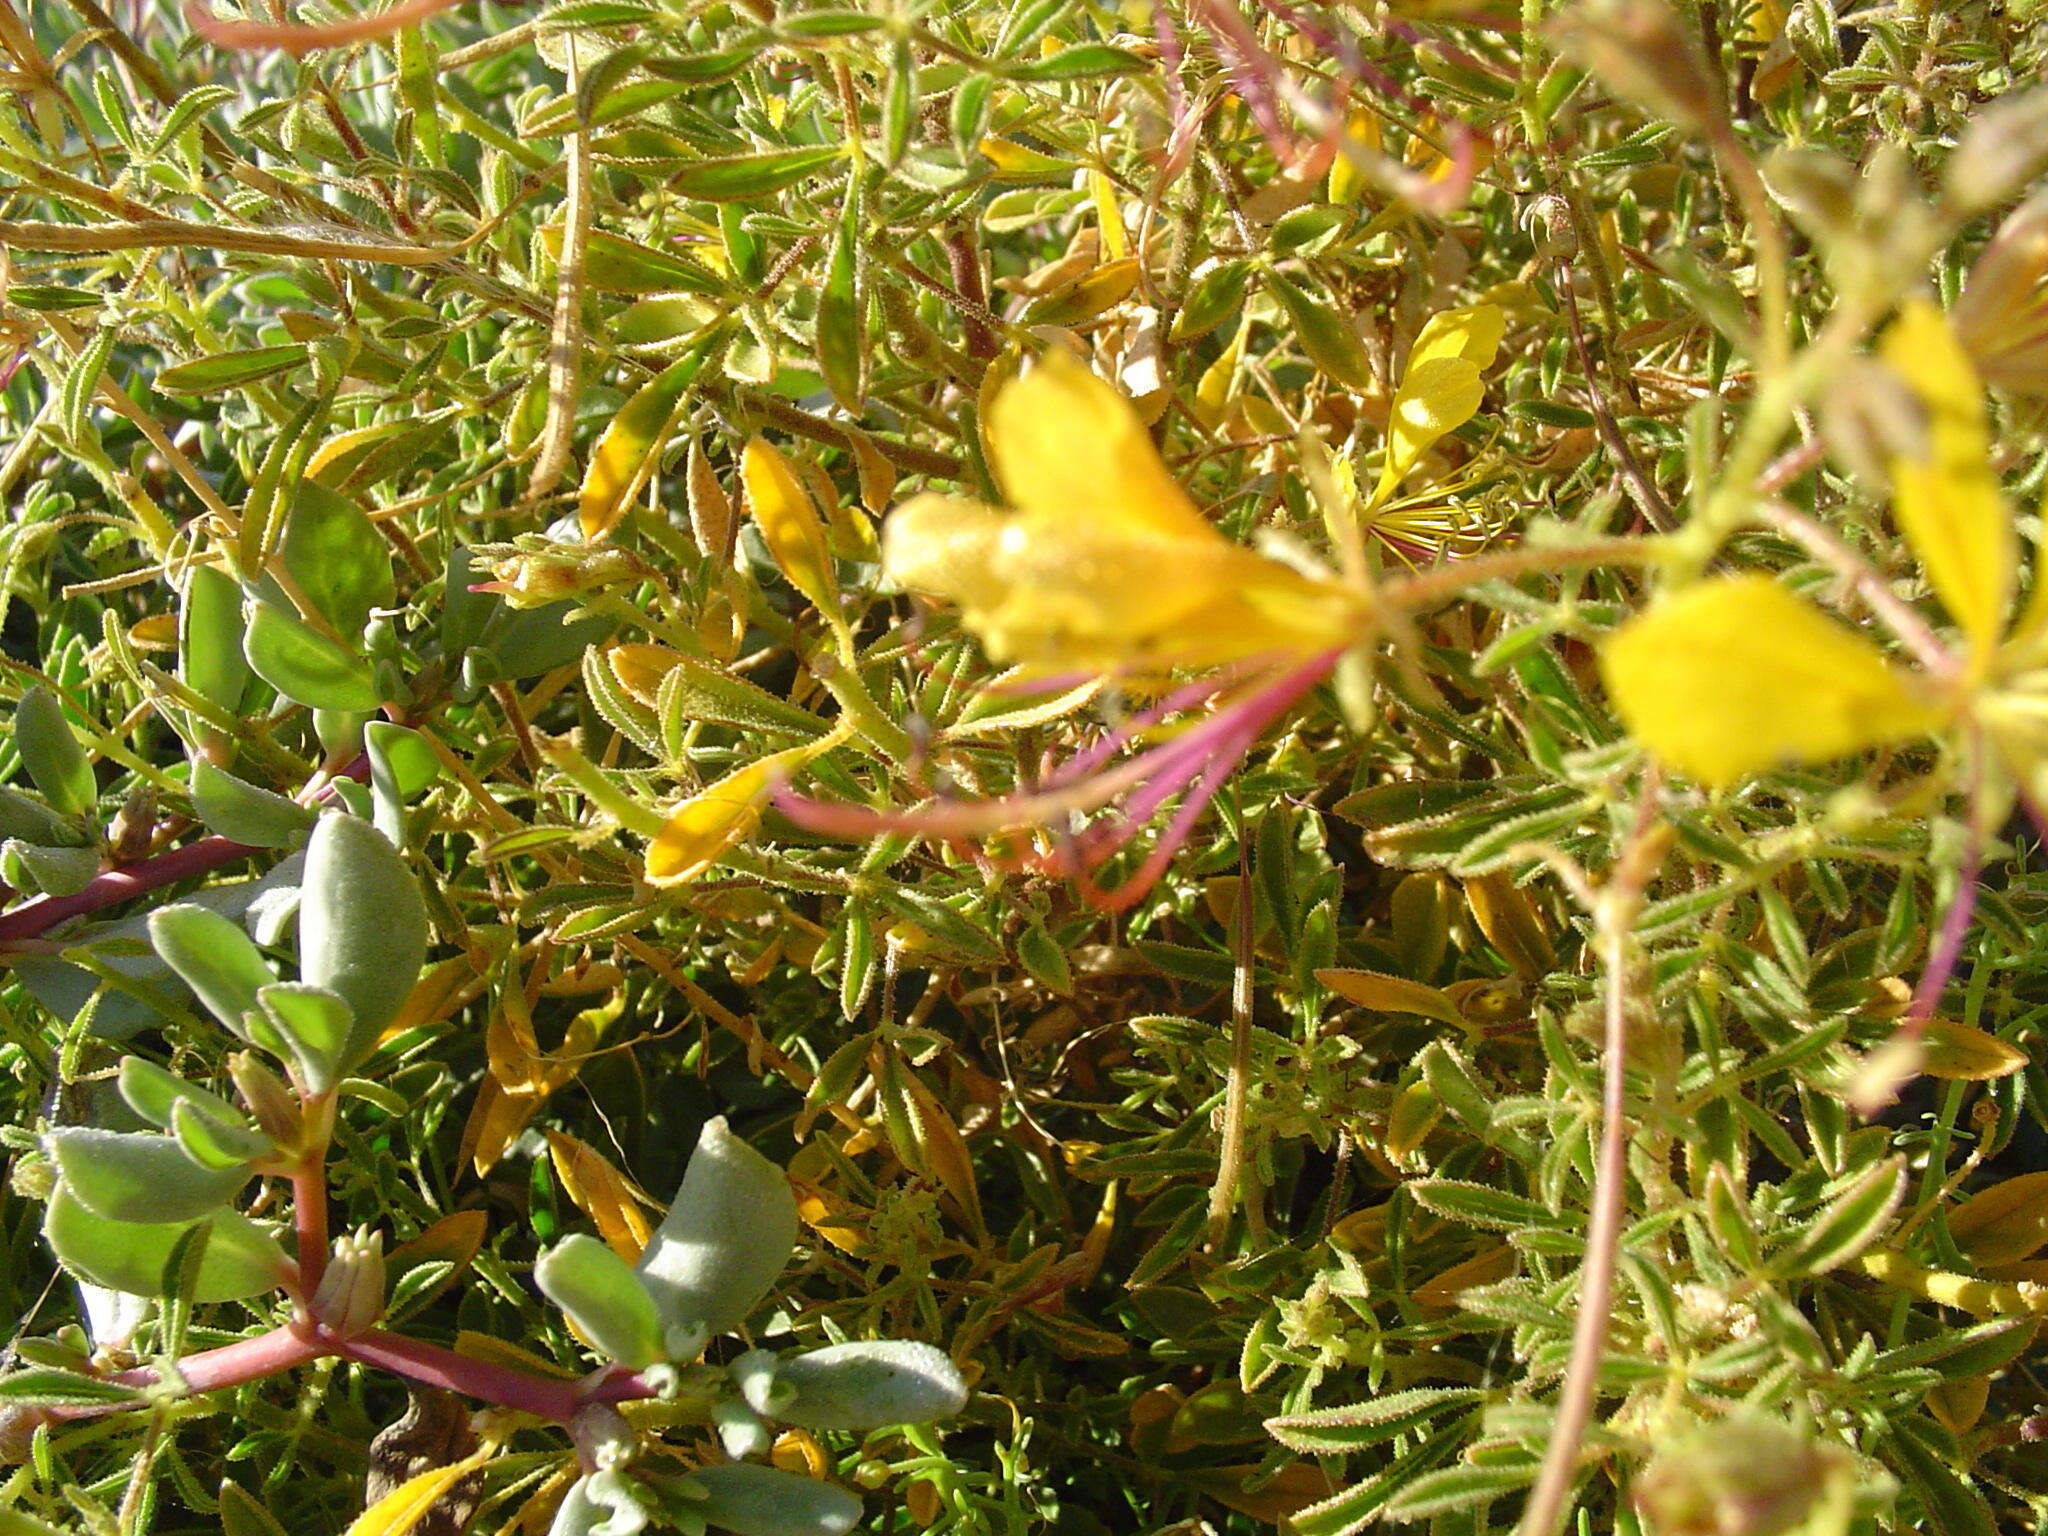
[299,813,426,1061]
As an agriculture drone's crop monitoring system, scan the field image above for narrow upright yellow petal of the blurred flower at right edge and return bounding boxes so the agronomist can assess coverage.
[1884,299,2019,657]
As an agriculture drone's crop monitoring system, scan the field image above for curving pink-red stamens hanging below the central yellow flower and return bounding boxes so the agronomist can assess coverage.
[776,651,1339,911]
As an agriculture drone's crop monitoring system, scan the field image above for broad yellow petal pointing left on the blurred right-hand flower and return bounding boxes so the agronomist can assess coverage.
[1599,575,1935,784]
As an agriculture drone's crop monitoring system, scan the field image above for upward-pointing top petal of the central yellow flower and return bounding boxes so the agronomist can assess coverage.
[989,350,1225,543]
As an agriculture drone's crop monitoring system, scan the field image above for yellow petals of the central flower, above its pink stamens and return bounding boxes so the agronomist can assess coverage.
[883,352,1362,672]
